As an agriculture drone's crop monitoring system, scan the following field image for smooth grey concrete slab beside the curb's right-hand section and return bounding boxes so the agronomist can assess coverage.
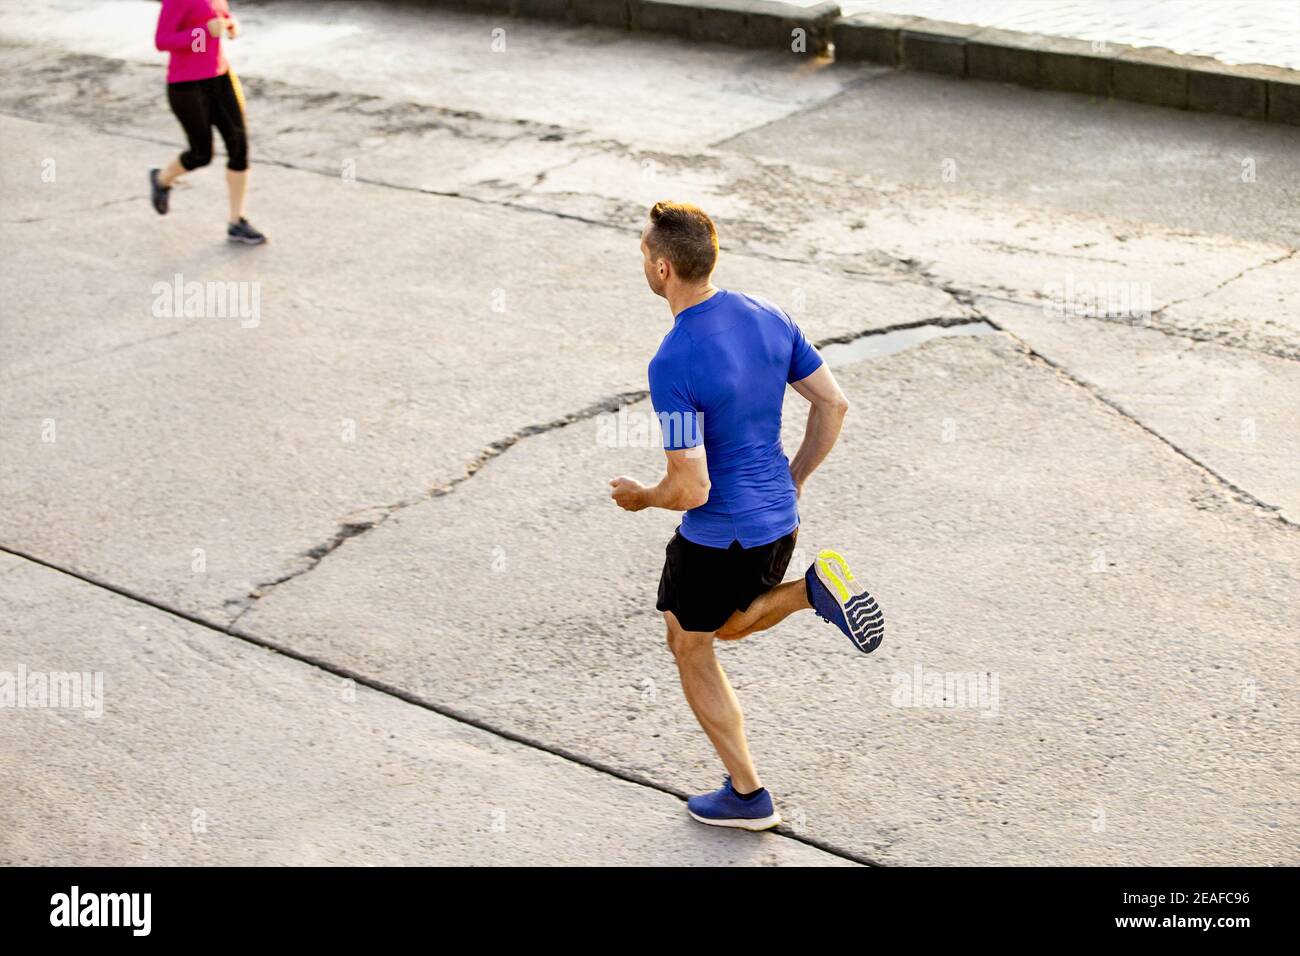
[724,65,1300,245]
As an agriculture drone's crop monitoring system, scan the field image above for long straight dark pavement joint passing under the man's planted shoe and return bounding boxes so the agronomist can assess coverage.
[0,544,883,866]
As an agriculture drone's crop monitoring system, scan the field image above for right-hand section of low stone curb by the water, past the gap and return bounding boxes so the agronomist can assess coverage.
[832,13,1300,125]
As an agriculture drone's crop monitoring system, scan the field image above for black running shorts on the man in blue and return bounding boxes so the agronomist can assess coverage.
[655,528,800,631]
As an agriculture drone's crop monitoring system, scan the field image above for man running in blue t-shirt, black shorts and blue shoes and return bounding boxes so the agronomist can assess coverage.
[610,202,884,830]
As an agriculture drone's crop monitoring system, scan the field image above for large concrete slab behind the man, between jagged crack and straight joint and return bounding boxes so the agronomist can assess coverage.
[231,336,1300,864]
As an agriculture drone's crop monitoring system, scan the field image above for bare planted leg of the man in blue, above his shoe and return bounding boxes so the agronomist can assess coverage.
[663,613,759,793]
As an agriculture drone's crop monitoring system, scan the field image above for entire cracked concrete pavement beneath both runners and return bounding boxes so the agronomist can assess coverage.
[0,3,1300,864]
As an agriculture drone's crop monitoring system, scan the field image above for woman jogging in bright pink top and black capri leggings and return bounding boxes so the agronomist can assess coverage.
[150,0,267,246]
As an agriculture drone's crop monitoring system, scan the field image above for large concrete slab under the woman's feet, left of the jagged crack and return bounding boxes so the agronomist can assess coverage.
[0,118,969,620]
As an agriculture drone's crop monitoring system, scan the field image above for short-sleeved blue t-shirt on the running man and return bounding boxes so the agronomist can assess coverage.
[650,289,822,548]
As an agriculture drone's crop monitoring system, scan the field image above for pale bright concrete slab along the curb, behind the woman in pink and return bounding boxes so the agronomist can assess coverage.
[0,0,880,146]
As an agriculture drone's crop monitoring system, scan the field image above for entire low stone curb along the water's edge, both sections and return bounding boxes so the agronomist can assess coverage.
[371,0,1300,125]
